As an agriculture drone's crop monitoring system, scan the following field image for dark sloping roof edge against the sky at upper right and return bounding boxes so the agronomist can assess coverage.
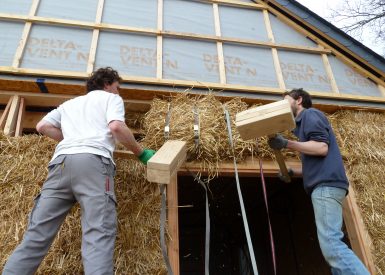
[266,0,385,78]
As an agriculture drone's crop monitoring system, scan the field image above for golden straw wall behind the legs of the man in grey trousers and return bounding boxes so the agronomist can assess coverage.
[0,133,166,274]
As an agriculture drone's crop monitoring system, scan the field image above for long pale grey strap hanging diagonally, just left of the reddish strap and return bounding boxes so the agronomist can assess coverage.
[223,106,258,275]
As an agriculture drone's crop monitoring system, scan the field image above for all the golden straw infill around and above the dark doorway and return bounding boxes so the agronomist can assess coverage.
[0,95,385,274]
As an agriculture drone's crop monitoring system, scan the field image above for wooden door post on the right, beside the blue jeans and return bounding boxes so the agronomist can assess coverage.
[343,186,376,274]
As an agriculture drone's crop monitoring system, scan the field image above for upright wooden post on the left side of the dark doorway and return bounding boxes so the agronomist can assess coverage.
[166,175,180,275]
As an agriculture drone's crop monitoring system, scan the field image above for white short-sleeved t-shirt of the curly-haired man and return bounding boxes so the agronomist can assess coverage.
[43,90,125,164]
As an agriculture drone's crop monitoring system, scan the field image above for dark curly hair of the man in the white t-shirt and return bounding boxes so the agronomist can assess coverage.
[87,67,122,93]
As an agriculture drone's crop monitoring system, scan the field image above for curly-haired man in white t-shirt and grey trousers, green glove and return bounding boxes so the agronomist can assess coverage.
[3,67,155,275]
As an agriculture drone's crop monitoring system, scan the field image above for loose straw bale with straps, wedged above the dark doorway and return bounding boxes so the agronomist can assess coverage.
[142,93,284,180]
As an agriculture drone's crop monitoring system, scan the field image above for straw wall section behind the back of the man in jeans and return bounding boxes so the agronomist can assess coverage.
[329,111,385,274]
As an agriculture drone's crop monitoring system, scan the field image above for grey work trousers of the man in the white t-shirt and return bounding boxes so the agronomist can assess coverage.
[3,154,116,275]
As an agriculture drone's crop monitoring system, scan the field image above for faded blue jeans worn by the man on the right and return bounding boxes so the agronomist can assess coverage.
[311,186,370,275]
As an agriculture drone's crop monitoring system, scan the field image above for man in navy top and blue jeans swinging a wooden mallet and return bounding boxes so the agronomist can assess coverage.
[269,89,369,275]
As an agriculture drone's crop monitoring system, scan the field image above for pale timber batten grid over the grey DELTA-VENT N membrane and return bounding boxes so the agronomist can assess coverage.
[0,0,385,103]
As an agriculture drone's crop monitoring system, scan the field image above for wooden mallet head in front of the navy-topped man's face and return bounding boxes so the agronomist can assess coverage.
[235,99,295,140]
